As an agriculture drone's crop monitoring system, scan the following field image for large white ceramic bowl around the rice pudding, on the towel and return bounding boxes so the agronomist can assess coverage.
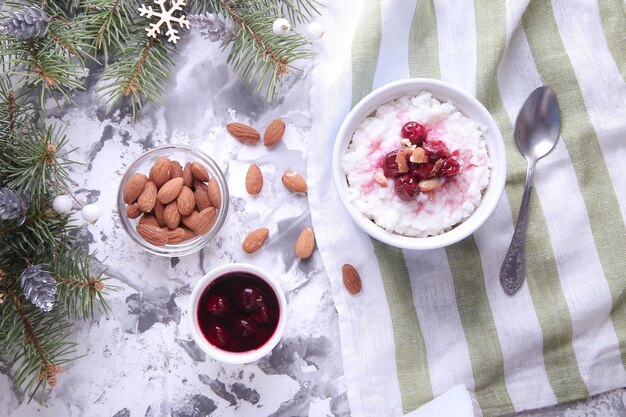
[332,78,506,250]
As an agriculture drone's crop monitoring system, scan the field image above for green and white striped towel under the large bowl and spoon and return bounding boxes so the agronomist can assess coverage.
[308,0,626,416]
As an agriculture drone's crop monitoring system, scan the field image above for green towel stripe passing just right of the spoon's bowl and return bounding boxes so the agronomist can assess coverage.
[523,2,626,391]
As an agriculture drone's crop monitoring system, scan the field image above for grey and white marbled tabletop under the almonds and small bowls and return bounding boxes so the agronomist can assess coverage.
[0,24,626,417]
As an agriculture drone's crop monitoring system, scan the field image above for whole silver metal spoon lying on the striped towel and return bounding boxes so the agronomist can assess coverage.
[500,86,561,295]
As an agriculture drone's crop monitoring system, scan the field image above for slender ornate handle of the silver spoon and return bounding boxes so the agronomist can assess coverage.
[500,161,535,295]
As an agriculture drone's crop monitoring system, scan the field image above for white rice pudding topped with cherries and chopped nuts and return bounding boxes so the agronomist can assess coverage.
[342,91,492,237]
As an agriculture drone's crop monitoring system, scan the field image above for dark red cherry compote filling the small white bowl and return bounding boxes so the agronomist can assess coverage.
[198,272,280,352]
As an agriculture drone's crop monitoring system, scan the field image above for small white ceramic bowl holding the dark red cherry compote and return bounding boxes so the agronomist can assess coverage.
[187,264,287,364]
